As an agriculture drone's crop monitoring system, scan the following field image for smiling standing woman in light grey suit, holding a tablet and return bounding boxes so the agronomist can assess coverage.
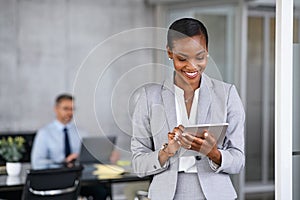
[131,18,245,200]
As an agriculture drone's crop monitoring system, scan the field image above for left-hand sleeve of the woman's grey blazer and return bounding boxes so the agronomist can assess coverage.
[131,88,169,177]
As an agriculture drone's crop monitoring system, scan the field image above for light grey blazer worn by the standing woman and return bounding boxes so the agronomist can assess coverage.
[131,74,245,200]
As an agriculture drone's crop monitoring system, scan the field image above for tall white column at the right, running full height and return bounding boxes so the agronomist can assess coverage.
[275,0,293,200]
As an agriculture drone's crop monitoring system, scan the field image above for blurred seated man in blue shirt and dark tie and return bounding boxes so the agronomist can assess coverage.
[31,94,107,199]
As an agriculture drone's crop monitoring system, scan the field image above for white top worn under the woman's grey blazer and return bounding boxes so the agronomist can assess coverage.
[174,85,199,173]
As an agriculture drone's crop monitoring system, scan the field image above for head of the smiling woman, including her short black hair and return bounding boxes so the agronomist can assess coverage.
[167,20,208,91]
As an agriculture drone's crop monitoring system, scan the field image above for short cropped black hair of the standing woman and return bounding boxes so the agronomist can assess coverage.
[167,18,208,49]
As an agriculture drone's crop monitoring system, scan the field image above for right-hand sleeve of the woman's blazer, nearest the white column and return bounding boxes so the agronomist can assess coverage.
[216,85,245,174]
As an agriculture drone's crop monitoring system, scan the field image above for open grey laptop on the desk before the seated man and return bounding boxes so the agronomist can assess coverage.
[79,136,116,164]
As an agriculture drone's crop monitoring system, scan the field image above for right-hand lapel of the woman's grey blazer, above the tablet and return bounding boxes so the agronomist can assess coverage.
[197,74,212,124]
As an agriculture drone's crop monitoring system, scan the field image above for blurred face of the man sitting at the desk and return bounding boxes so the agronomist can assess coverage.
[54,99,73,124]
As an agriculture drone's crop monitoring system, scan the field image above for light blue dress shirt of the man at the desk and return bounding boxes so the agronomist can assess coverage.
[31,120,86,169]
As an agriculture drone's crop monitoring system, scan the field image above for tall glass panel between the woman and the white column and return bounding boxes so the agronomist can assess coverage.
[246,13,275,183]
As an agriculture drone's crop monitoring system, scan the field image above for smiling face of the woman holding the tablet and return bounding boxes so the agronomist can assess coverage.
[168,35,208,89]
